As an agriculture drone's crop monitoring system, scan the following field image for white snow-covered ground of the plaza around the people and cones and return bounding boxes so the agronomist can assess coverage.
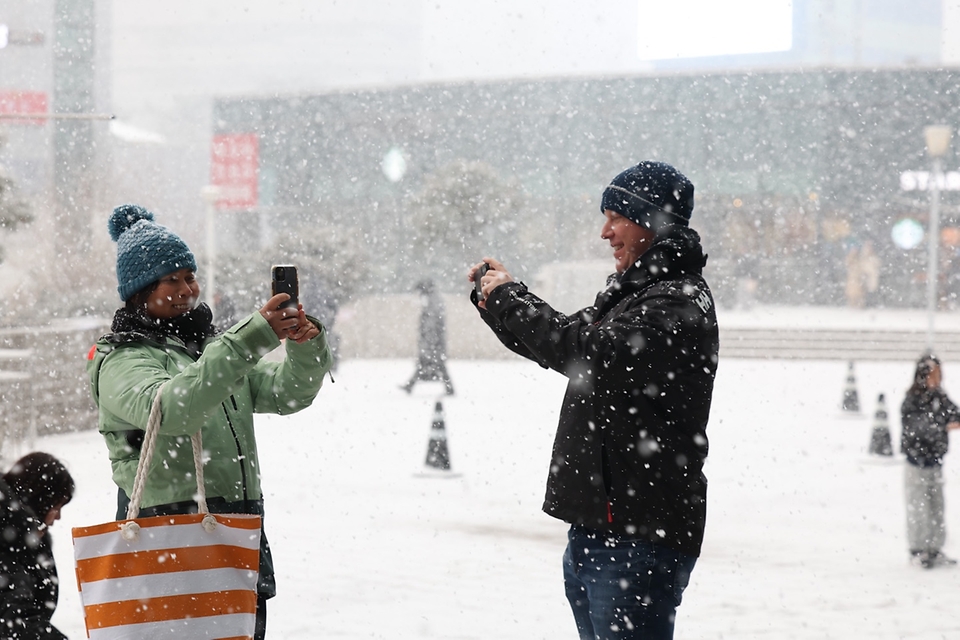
[37,360,960,640]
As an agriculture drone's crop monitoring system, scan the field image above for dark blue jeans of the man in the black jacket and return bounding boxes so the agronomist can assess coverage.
[563,525,697,640]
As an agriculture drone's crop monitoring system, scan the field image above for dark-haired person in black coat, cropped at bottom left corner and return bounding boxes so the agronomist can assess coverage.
[0,452,74,640]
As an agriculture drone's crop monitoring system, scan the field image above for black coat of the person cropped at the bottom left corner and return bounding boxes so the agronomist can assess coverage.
[0,479,66,640]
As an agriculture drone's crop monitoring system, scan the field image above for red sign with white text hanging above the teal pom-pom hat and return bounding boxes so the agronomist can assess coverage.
[210,133,260,209]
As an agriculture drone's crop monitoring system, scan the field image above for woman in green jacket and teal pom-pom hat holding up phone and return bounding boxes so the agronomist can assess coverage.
[87,205,332,638]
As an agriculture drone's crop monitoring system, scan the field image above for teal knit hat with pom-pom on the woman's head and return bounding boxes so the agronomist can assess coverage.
[108,204,197,302]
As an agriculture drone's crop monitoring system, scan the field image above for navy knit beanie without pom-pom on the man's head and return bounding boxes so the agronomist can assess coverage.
[600,160,693,231]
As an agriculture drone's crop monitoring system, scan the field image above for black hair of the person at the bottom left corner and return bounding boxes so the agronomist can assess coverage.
[3,451,75,521]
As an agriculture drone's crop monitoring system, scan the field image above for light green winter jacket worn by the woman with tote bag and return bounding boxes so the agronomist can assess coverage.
[87,313,333,508]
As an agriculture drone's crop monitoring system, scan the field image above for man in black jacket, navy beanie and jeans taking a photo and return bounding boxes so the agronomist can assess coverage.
[468,162,719,640]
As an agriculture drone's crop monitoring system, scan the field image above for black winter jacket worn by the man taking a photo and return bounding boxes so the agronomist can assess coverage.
[472,226,719,556]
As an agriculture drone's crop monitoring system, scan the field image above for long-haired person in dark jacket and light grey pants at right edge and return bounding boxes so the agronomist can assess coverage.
[900,353,960,569]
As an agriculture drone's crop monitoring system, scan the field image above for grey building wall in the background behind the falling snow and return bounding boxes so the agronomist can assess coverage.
[214,70,960,305]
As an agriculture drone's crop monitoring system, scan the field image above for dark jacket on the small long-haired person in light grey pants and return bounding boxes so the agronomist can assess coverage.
[900,388,960,467]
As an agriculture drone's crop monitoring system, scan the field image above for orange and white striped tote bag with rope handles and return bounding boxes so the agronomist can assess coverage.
[73,390,260,640]
